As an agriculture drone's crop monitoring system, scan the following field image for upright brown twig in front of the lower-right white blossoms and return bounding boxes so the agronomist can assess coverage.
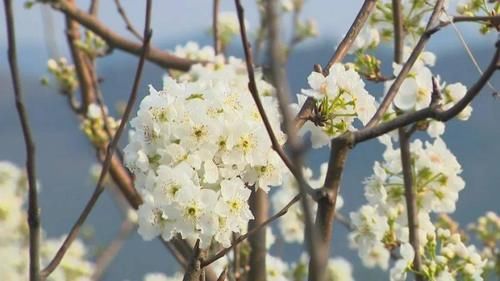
[398,127,424,281]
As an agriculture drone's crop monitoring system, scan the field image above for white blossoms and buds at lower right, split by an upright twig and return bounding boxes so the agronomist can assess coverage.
[349,138,485,281]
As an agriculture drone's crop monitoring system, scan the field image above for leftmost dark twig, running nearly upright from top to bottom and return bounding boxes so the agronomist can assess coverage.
[4,0,40,281]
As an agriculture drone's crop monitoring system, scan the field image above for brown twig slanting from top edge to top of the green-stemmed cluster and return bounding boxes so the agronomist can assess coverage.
[323,0,377,75]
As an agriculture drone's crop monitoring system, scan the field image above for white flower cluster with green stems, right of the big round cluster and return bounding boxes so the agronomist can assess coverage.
[293,63,376,148]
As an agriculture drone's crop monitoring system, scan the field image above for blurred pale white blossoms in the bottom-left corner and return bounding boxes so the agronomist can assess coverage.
[0,161,94,281]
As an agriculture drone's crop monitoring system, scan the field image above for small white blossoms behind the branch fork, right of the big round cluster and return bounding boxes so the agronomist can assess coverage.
[271,163,343,243]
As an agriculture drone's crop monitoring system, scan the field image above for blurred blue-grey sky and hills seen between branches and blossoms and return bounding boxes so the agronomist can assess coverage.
[0,0,500,280]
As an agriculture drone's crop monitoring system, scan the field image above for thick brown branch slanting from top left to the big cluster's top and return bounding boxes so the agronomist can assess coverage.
[48,1,195,70]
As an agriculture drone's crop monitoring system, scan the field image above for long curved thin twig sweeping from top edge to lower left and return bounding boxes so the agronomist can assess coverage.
[42,0,152,279]
